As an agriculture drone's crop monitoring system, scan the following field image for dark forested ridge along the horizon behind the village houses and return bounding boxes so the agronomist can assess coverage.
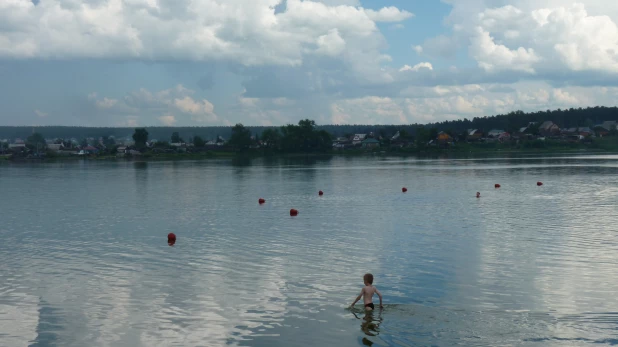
[0,106,618,143]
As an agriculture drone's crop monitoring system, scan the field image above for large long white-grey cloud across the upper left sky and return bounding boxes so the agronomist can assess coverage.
[0,0,404,78]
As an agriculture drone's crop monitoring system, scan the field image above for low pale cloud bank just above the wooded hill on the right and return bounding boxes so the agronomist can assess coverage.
[330,82,618,124]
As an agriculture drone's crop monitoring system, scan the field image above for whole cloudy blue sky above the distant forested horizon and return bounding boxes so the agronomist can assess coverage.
[0,0,618,127]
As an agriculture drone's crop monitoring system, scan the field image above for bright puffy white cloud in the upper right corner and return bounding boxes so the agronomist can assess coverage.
[436,0,618,73]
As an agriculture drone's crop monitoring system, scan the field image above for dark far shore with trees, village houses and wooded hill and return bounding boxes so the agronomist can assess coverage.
[0,107,618,160]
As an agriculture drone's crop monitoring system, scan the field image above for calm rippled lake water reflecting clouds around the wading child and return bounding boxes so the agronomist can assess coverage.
[0,156,618,347]
